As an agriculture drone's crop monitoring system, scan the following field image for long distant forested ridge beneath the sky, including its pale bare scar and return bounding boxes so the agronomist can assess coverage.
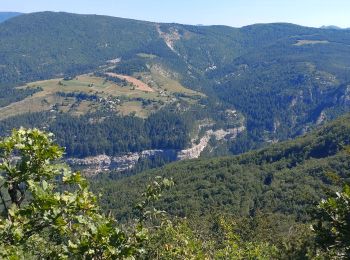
[0,12,334,86]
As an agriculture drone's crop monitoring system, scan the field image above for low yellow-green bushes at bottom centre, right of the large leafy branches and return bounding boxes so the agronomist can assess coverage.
[145,218,278,259]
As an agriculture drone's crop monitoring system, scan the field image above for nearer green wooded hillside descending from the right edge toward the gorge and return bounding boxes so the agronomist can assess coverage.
[92,112,350,220]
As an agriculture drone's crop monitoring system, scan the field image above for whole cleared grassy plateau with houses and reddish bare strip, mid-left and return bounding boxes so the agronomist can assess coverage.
[0,70,204,120]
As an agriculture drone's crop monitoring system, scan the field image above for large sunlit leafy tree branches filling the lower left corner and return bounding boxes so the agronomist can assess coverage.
[0,129,149,259]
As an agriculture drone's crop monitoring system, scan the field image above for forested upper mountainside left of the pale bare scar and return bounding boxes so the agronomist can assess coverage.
[0,12,163,83]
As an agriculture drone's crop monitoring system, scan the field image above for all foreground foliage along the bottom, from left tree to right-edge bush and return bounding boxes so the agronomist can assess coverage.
[0,128,350,259]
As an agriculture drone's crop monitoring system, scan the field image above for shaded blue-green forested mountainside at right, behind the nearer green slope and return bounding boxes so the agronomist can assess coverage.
[210,25,350,145]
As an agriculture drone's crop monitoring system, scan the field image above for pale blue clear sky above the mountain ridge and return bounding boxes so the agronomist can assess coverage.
[0,0,350,27]
